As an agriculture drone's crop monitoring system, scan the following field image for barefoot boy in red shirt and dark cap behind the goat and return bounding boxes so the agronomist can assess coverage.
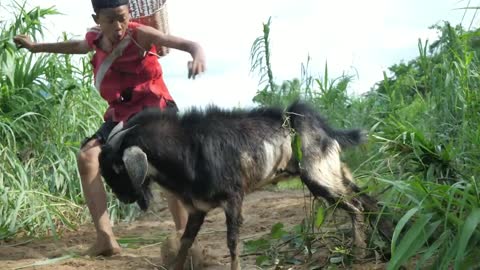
[14,0,205,256]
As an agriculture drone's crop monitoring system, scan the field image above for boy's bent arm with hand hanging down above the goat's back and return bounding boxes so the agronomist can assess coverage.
[137,26,206,78]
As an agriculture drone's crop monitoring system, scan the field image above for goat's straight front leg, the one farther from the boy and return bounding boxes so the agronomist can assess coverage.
[225,196,243,270]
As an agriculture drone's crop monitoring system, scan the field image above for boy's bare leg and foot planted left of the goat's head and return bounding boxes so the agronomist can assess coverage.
[78,139,120,256]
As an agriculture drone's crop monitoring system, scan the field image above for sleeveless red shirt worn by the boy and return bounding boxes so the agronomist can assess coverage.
[85,22,173,122]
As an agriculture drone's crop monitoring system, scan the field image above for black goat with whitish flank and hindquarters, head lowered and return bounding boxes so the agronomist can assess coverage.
[100,102,392,269]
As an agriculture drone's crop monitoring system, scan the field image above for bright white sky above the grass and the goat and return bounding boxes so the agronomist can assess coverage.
[0,0,478,109]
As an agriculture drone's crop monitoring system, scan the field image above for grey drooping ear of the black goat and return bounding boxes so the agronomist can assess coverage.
[122,146,148,187]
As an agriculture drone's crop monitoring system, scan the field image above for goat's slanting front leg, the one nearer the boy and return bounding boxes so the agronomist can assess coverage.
[174,211,206,270]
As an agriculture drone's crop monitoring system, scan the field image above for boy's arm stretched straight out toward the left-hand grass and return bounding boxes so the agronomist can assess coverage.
[13,35,92,54]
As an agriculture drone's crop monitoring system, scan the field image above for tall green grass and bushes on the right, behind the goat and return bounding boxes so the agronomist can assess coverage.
[252,17,480,269]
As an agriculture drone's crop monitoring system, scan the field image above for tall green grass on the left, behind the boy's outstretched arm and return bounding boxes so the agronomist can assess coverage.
[0,5,137,240]
